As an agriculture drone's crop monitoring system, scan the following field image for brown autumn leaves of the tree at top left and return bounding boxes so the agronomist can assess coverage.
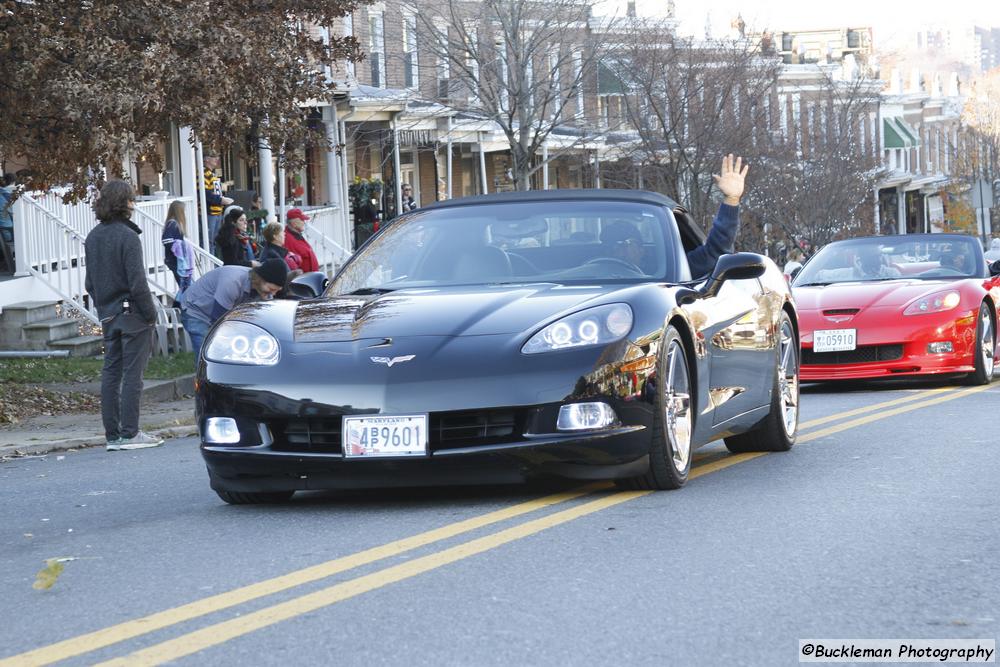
[0,0,357,194]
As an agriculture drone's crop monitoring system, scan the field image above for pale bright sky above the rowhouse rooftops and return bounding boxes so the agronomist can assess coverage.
[660,0,1000,45]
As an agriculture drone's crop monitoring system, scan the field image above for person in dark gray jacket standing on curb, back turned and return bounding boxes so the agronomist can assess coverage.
[84,181,163,451]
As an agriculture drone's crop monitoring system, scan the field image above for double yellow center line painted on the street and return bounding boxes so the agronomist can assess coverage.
[0,385,989,667]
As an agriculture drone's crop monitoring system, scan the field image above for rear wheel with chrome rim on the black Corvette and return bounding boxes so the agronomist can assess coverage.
[725,311,799,454]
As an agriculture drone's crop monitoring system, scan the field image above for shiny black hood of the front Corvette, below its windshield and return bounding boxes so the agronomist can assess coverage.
[294,283,632,342]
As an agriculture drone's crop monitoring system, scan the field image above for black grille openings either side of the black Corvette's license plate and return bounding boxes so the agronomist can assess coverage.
[269,409,526,454]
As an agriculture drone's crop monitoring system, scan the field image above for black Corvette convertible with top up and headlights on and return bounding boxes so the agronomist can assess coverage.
[197,190,799,503]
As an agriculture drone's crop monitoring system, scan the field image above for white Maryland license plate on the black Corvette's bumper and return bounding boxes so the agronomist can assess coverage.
[343,415,427,459]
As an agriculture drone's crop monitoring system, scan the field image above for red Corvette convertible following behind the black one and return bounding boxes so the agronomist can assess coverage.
[792,234,1000,384]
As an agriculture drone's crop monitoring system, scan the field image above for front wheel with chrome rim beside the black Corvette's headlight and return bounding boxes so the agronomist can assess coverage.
[617,326,697,490]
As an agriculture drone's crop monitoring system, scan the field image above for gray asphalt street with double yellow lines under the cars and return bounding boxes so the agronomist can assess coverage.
[0,384,1000,666]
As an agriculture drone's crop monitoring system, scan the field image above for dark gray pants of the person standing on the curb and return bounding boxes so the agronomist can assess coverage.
[101,313,153,440]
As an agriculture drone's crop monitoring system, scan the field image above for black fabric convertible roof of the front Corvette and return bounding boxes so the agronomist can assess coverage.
[422,188,705,249]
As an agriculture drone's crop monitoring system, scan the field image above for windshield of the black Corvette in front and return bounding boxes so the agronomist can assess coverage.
[327,200,687,294]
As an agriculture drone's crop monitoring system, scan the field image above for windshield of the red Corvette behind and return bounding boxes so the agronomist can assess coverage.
[792,234,986,287]
